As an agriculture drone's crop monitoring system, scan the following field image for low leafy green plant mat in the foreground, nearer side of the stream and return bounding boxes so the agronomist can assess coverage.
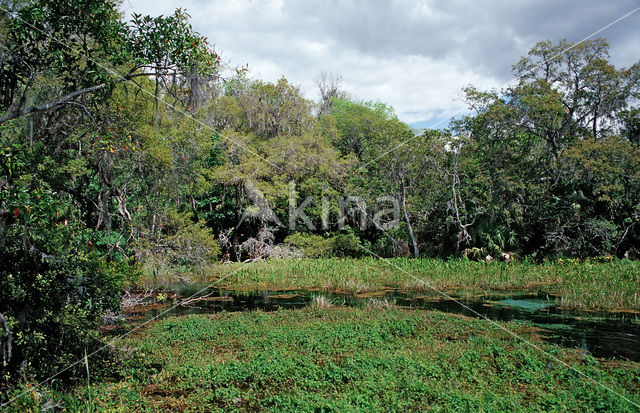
[14,308,640,412]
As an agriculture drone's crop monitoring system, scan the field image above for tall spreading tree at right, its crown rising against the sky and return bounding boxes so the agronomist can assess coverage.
[458,39,637,255]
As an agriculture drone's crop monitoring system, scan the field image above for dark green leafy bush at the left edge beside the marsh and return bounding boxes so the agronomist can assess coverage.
[0,145,132,384]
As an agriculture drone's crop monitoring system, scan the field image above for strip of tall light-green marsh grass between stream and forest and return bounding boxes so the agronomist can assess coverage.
[164,258,640,310]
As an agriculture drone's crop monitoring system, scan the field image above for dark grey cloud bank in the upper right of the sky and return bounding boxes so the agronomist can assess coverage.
[284,0,640,78]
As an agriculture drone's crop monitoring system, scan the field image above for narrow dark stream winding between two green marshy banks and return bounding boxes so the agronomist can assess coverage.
[130,285,640,361]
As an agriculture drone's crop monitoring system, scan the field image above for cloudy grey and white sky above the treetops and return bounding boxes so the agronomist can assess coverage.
[122,0,640,127]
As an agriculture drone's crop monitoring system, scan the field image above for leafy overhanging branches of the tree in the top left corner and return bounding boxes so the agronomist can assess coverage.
[0,0,219,123]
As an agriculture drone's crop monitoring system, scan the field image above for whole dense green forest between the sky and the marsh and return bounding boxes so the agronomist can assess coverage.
[0,0,640,394]
